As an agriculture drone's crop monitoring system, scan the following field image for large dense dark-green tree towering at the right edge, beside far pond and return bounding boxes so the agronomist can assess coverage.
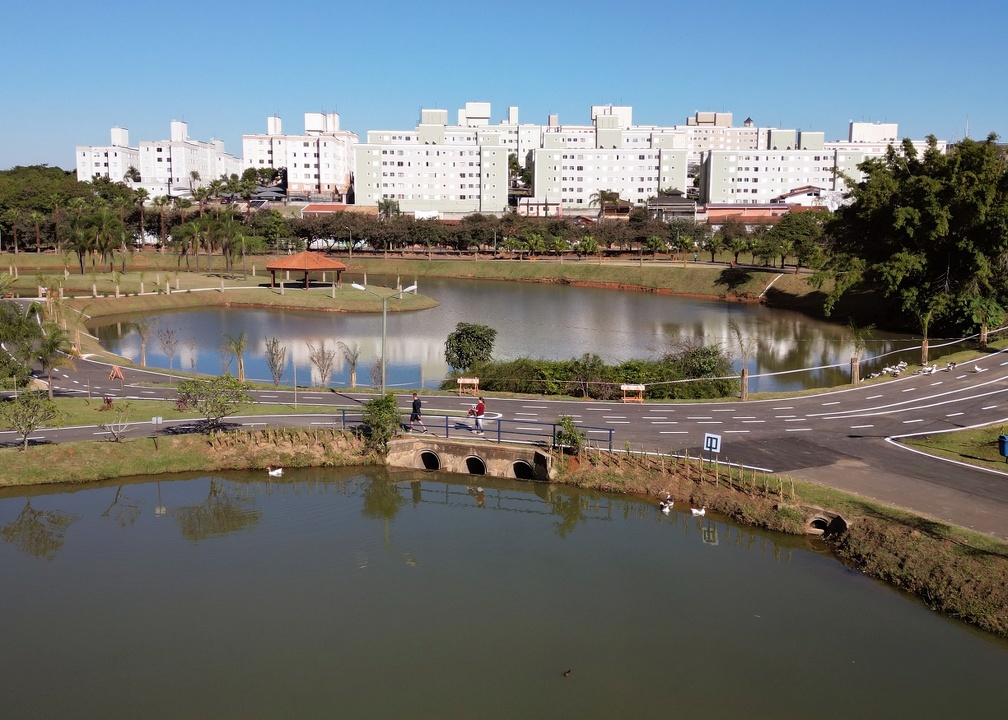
[813,134,1008,342]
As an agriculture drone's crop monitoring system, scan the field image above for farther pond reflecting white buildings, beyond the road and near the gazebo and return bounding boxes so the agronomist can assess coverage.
[94,277,936,392]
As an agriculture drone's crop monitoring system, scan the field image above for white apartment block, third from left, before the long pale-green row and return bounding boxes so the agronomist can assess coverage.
[242,113,358,201]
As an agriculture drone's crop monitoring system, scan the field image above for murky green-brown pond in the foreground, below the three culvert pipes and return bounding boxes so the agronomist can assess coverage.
[0,469,1008,719]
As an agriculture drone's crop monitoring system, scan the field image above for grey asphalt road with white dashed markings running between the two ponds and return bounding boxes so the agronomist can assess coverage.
[7,353,1008,539]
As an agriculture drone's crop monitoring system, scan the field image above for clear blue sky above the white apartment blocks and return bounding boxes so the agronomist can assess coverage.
[0,0,1008,169]
